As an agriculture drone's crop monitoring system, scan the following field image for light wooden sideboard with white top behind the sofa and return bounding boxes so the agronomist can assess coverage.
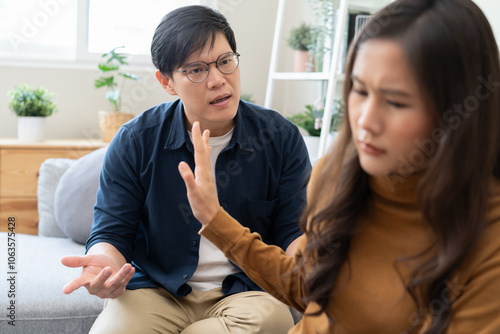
[0,139,106,234]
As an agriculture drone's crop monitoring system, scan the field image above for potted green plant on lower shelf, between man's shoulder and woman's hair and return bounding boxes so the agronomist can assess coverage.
[288,100,342,160]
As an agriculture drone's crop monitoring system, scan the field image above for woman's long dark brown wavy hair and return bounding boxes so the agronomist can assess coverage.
[299,0,500,334]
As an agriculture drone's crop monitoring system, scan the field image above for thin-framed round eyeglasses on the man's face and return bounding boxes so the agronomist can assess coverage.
[176,52,240,83]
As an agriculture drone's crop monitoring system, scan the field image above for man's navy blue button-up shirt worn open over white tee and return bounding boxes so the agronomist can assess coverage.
[87,100,311,297]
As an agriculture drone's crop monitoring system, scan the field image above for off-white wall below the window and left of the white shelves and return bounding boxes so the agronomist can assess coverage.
[0,0,282,139]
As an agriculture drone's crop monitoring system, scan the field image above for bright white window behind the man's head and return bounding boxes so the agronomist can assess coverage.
[0,0,215,63]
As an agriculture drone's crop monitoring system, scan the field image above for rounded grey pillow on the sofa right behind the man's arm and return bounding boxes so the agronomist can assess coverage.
[54,146,107,244]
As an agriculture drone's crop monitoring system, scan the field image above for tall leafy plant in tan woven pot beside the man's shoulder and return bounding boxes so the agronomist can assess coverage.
[94,46,141,142]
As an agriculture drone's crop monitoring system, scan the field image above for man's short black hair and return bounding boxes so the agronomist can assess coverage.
[151,6,236,77]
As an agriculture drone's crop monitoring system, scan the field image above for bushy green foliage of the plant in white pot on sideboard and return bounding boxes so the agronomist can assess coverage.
[7,84,57,117]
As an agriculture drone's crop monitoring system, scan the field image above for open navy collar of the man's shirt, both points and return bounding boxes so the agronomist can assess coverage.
[163,100,256,152]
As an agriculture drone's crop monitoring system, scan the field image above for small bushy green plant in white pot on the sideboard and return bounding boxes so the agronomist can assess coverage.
[7,84,57,142]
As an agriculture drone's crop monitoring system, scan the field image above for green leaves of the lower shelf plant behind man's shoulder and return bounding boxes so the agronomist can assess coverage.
[288,100,342,136]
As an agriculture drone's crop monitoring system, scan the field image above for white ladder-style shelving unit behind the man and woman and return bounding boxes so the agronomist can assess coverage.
[264,0,390,158]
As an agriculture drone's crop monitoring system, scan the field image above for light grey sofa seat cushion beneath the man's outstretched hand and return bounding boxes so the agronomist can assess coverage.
[0,232,104,334]
